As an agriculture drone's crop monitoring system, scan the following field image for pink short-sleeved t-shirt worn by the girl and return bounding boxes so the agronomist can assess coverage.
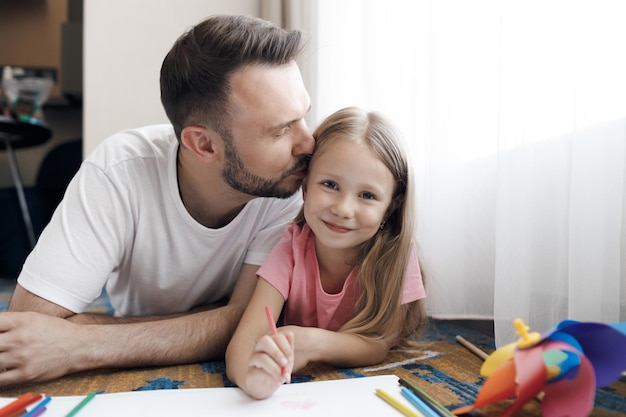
[257,224,426,331]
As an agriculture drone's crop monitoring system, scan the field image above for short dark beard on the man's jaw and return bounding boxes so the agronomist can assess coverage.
[222,134,310,198]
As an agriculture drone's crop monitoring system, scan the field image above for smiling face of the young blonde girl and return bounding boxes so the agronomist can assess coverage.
[303,140,395,254]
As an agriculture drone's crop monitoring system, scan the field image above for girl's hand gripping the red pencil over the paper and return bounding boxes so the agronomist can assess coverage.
[245,332,294,400]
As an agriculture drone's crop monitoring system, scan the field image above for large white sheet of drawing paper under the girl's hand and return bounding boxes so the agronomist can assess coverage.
[0,375,412,417]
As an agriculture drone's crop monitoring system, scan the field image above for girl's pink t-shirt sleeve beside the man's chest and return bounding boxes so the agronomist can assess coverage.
[257,224,297,300]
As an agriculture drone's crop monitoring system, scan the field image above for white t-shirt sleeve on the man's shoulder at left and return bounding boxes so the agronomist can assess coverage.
[18,163,129,313]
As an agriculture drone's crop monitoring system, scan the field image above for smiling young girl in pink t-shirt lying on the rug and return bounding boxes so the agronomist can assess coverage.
[226,108,426,399]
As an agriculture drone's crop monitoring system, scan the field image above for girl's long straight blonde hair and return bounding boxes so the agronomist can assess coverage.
[295,107,426,344]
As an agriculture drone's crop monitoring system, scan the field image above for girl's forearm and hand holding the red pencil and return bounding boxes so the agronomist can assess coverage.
[226,278,294,399]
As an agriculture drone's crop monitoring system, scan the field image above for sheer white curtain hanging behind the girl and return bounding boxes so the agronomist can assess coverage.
[282,0,626,346]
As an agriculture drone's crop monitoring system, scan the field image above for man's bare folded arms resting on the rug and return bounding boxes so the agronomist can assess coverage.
[0,265,258,387]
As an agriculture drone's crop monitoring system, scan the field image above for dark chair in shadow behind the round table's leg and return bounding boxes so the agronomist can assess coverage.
[0,139,83,278]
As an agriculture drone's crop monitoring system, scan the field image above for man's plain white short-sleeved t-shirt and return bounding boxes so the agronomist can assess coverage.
[18,125,302,316]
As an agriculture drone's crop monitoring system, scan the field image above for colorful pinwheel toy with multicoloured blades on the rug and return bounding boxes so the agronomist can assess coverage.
[452,319,626,417]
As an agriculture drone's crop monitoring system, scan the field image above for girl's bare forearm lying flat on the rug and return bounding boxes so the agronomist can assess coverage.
[279,326,391,370]
